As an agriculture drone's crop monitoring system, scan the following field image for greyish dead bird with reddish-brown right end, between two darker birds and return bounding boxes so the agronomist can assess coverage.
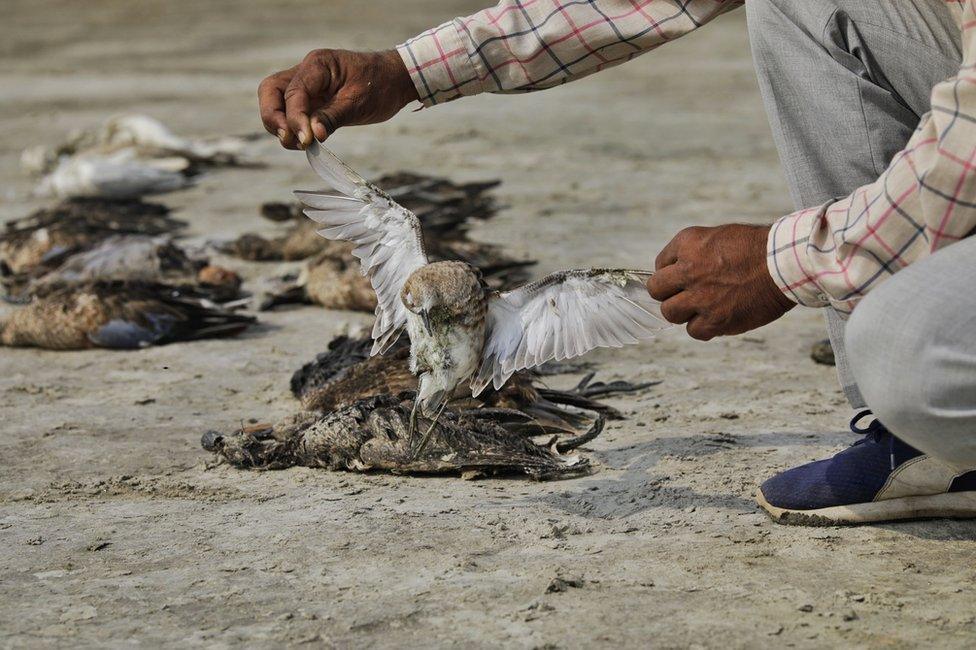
[0,235,241,303]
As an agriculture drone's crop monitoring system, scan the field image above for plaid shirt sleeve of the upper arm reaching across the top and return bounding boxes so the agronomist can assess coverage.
[397,0,742,106]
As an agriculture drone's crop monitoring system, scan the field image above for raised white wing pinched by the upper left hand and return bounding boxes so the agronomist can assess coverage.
[295,142,427,354]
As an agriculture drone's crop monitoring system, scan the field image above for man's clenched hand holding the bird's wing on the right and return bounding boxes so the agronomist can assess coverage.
[647,225,795,341]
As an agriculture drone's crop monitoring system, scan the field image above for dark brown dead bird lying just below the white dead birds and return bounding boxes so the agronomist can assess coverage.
[0,198,186,274]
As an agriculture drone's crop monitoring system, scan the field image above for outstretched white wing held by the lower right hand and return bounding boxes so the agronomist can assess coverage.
[471,269,668,396]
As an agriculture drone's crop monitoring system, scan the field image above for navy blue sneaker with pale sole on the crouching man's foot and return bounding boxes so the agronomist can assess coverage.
[756,411,976,526]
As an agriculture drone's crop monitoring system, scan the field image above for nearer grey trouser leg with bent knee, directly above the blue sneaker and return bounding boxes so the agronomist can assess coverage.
[846,237,976,469]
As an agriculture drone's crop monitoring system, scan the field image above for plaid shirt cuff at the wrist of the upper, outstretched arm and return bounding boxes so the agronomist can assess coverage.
[397,21,484,107]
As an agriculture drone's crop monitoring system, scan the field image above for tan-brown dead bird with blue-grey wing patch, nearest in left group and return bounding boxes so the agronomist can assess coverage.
[0,280,255,350]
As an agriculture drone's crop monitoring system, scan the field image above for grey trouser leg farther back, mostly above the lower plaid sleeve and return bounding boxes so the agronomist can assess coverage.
[746,0,961,408]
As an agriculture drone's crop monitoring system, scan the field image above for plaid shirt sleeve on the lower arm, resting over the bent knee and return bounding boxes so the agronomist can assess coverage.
[767,0,976,313]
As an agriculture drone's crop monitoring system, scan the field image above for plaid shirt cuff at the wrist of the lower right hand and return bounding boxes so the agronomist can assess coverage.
[766,208,833,307]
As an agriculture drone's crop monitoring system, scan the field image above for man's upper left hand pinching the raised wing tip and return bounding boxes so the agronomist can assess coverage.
[258,50,417,149]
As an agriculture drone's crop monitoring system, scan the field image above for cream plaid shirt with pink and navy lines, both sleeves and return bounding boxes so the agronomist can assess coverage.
[398,0,976,312]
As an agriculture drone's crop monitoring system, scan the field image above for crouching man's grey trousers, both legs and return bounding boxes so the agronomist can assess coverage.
[746,0,976,467]
